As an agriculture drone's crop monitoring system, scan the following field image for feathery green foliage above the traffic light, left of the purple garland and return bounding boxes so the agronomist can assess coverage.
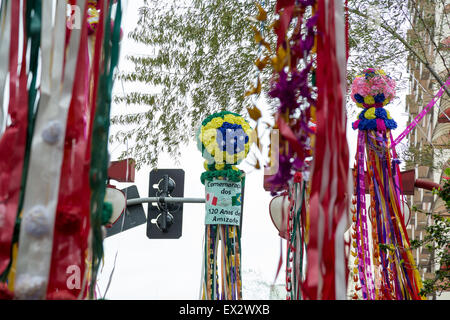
[112,0,264,167]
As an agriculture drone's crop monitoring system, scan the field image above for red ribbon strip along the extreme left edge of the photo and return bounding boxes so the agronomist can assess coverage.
[0,0,28,274]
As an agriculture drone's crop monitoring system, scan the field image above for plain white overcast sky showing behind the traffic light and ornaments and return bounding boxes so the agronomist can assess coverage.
[98,0,407,299]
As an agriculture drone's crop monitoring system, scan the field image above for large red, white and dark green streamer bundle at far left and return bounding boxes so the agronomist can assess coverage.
[0,0,122,299]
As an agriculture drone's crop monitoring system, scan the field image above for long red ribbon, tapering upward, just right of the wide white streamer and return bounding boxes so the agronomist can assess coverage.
[47,0,90,299]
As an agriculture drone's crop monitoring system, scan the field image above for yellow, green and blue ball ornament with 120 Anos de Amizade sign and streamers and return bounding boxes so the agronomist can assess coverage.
[197,111,252,300]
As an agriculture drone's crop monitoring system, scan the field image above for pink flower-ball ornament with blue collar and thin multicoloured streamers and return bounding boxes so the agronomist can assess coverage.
[351,68,421,300]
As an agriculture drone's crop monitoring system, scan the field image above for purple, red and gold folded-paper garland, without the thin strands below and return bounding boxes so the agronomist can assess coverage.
[266,1,318,193]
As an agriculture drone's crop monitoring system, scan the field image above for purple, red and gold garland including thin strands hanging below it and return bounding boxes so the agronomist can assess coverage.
[246,0,318,299]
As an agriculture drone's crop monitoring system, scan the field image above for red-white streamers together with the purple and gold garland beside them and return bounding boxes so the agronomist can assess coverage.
[255,0,351,300]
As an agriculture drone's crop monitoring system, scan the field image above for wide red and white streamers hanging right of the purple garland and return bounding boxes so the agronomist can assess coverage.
[303,0,352,300]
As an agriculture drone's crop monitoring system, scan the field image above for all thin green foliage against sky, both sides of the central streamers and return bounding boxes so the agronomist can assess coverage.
[110,0,448,168]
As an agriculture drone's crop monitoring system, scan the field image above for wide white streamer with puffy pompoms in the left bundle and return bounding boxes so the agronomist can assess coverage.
[15,0,86,299]
